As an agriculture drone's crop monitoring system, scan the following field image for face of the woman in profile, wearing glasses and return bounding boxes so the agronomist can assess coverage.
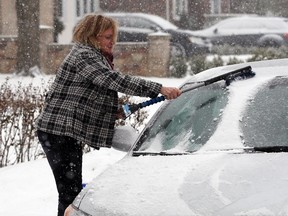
[97,28,114,53]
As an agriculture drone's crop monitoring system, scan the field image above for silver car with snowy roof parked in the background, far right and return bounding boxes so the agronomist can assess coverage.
[194,16,288,47]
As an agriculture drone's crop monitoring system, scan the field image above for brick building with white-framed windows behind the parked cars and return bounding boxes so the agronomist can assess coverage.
[0,0,230,44]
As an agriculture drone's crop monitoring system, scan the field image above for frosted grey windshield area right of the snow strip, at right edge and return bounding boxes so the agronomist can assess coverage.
[241,77,288,147]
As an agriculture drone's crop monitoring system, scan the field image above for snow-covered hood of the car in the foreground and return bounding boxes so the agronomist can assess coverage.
[74,151,288,216]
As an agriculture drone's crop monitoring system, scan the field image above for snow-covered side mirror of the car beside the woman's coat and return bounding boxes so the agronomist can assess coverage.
[112,125,139,152]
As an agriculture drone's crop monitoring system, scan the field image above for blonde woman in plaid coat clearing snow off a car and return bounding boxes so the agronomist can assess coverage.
[36,14,181,216]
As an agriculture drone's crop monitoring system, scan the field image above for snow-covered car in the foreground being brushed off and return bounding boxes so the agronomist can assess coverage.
[69,59,288,216]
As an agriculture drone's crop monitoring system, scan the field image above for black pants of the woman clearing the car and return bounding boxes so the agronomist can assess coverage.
[37,130,82,216]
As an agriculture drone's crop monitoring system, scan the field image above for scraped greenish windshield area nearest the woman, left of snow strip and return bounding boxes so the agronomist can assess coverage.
[136,84,228,152]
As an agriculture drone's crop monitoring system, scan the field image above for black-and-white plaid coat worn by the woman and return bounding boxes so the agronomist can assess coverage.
[36,43,161,148]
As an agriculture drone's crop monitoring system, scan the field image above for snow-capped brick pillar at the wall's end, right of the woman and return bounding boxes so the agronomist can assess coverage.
[147,32,171,77]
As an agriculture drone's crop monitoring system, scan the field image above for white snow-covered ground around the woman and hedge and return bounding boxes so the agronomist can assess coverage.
[0,74,188,216]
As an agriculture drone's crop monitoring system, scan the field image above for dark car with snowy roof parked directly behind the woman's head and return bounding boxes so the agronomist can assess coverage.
[103,12,211,57]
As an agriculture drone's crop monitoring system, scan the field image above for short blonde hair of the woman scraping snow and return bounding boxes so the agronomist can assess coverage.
[73,14,118,48]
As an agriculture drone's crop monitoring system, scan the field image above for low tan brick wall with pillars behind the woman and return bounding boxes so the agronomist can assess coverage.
[0,33,170,77]
